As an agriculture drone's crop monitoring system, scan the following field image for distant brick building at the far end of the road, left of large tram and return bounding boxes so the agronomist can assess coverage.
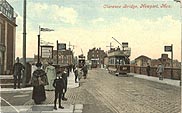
[87,47,107,67]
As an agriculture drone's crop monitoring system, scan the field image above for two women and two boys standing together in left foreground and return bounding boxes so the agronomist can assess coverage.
[31,62,69,110]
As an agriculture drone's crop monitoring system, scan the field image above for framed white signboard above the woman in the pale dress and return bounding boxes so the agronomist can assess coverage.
[41,46,53,58]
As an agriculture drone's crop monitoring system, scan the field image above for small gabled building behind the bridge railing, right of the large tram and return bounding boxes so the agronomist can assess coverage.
[135,55,151,66]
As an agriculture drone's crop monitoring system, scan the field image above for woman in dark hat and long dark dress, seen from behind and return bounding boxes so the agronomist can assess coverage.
[31,63,48,104]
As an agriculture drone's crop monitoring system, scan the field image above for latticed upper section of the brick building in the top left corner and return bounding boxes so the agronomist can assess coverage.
[0,0,14,20]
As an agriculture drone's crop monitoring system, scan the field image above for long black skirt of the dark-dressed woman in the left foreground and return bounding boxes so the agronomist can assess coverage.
[32,85,46,104]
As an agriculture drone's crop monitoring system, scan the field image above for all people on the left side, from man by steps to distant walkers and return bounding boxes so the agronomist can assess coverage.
[13,57,88,110]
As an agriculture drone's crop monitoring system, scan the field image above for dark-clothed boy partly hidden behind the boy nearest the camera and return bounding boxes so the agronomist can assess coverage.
[62,67,68,101]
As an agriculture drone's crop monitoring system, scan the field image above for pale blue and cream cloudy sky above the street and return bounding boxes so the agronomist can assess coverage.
[7,0,181,61]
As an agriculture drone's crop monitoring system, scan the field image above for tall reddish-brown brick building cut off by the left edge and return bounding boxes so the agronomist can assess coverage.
[0,0,17,74]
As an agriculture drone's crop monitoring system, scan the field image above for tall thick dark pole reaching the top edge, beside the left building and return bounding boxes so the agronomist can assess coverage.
[22,0,27,87]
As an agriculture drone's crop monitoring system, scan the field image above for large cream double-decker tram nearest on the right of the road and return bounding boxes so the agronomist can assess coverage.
[107,47,131,76]
